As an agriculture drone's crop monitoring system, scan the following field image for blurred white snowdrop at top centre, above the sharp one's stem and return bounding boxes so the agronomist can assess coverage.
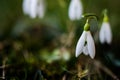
[68,0,83,20]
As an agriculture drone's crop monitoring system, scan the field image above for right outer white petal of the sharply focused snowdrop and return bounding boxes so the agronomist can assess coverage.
[87,31,95,59]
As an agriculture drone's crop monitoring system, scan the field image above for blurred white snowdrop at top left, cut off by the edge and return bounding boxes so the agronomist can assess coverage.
[23,0,45,18]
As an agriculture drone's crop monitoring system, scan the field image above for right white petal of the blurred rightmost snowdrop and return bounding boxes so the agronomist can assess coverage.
[104,22,112,44]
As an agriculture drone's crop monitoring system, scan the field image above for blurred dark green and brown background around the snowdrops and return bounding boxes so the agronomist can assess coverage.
[0,0,120,80]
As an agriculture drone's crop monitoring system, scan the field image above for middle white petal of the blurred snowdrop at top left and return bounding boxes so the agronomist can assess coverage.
[30,0,38,18]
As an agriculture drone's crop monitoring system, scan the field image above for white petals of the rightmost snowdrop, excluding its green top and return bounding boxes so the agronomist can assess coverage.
[99,22,112,44]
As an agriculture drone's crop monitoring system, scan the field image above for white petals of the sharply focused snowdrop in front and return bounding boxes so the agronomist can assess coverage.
[76,31,95,59]
